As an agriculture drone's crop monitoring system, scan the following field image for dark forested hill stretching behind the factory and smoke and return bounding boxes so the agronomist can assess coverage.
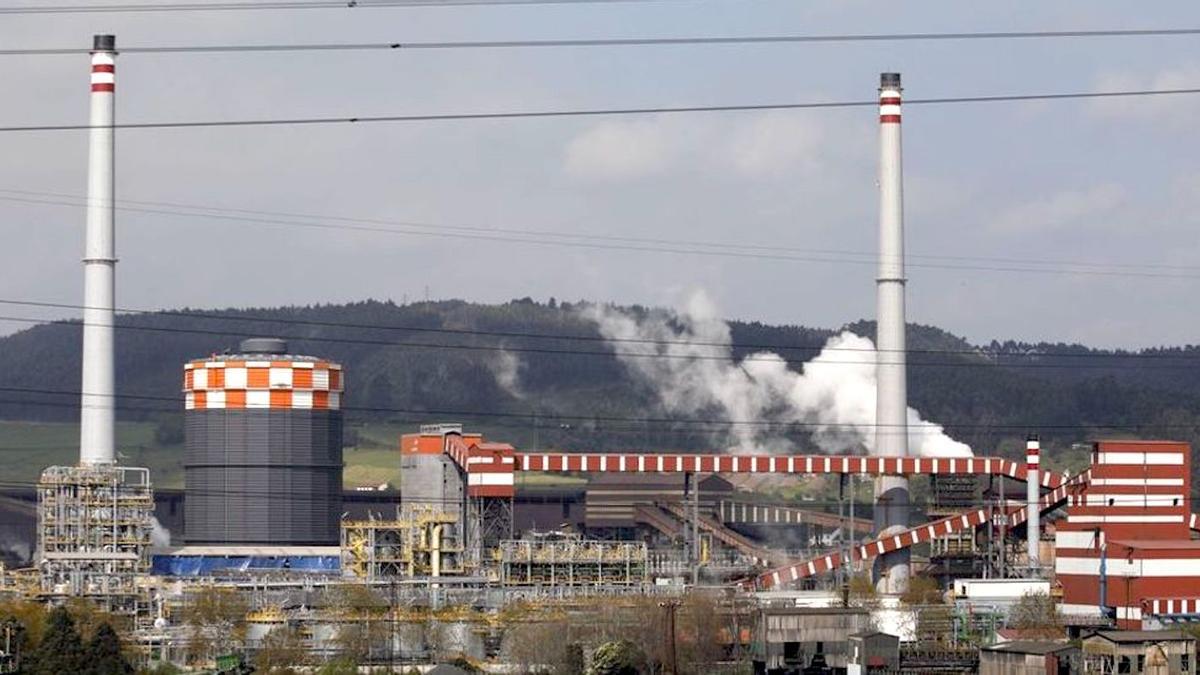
[0,299,1200,453]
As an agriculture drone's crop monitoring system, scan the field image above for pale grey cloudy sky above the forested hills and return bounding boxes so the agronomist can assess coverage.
[0,0,1200,346]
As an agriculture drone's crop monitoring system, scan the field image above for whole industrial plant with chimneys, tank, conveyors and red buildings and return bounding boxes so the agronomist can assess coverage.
[0,35,1200,675]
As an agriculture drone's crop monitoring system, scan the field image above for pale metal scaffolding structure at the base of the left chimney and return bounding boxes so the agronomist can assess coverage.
[37,465,154,614]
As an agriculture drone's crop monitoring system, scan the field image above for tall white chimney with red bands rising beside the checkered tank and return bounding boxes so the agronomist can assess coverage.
[79,35,116,465]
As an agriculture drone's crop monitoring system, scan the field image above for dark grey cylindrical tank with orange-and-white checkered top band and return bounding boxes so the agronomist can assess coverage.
[184,339,343,545]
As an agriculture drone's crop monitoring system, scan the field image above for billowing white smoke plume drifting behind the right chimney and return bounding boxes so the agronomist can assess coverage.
[582,292,971,456]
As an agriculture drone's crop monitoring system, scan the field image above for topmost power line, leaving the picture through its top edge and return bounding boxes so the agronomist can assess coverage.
[0,0,647,14]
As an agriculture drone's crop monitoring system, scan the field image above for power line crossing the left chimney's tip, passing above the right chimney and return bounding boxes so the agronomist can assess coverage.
[7,27,1200,56]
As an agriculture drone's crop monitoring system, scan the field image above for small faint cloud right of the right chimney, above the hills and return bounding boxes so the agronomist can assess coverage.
[990,183,1127,234]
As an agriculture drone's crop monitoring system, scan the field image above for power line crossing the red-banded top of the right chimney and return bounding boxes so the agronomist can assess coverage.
[0,88,1200,132]
